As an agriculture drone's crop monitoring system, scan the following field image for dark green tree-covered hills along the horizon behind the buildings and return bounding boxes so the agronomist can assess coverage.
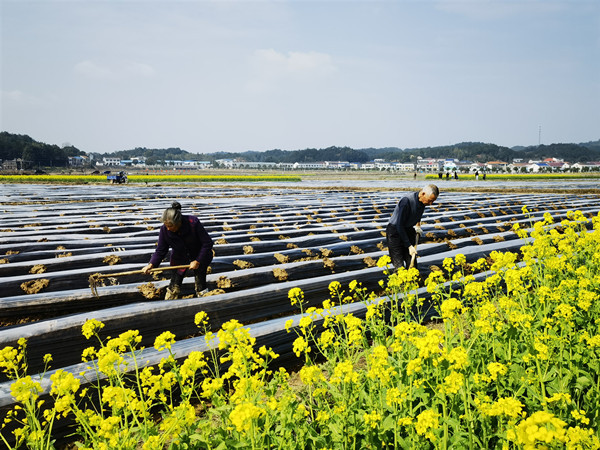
[0,132,600,167]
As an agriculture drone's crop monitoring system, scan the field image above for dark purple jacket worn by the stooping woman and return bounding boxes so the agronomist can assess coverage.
[150,215,213,268]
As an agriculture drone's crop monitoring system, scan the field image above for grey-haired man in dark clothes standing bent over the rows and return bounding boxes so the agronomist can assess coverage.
[385,184,440,269]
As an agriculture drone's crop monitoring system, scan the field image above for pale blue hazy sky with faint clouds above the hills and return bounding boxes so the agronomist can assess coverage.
[0,0,600,153]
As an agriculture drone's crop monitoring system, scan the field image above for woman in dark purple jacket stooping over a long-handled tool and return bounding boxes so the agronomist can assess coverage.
[142,202,213,300]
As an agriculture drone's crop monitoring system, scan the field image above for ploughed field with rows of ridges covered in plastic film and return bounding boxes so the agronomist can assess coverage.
[0,180,600,446]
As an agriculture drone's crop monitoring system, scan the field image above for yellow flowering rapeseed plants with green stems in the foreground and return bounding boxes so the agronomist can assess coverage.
[0,208,600,449]
